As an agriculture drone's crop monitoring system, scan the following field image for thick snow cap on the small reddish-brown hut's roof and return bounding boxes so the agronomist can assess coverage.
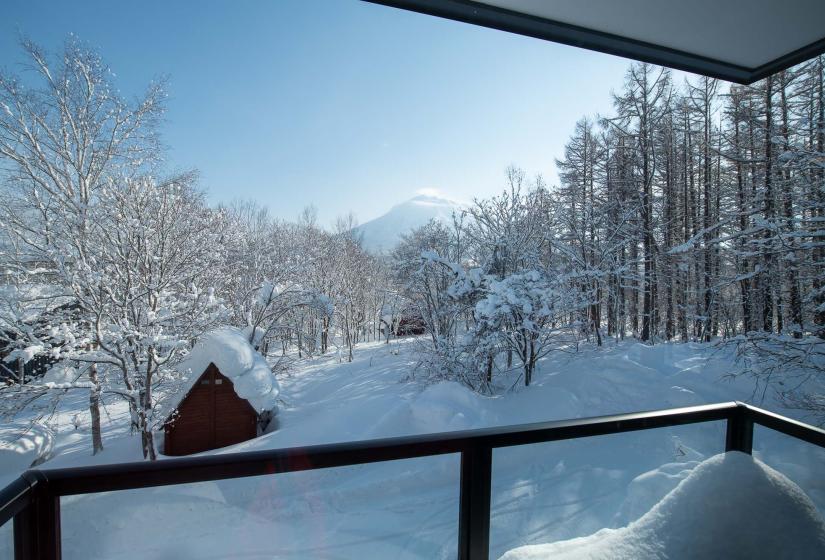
[179,327,281,412]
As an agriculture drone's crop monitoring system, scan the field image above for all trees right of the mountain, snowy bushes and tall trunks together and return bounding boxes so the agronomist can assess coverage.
[393,57,825,411]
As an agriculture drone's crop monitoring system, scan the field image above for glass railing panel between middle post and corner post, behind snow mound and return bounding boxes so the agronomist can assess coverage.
[490,422,725,558]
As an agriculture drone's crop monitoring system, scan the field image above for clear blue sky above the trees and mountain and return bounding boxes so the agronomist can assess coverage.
[0,0,629,224]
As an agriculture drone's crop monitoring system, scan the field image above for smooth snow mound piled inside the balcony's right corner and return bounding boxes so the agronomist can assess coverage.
[501,452,825,560]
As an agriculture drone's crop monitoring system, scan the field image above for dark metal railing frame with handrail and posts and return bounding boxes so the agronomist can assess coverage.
[0,402,825,560]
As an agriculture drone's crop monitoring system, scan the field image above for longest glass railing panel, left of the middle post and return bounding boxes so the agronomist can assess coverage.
[61,455,460,560]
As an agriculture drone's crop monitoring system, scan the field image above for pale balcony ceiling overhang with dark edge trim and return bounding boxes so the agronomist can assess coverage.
[367,0,825,84]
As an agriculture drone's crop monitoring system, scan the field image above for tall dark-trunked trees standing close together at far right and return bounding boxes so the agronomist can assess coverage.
[557,57,825,341]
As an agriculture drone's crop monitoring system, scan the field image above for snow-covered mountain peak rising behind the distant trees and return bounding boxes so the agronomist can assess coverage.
[355,194,463,253]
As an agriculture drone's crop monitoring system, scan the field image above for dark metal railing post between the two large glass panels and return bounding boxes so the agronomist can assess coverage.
[458,447,493,560]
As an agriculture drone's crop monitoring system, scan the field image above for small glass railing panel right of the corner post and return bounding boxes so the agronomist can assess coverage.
[753,425,825,515]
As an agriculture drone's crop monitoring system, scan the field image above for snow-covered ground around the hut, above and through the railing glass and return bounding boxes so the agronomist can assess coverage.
[0,340,825,559]
